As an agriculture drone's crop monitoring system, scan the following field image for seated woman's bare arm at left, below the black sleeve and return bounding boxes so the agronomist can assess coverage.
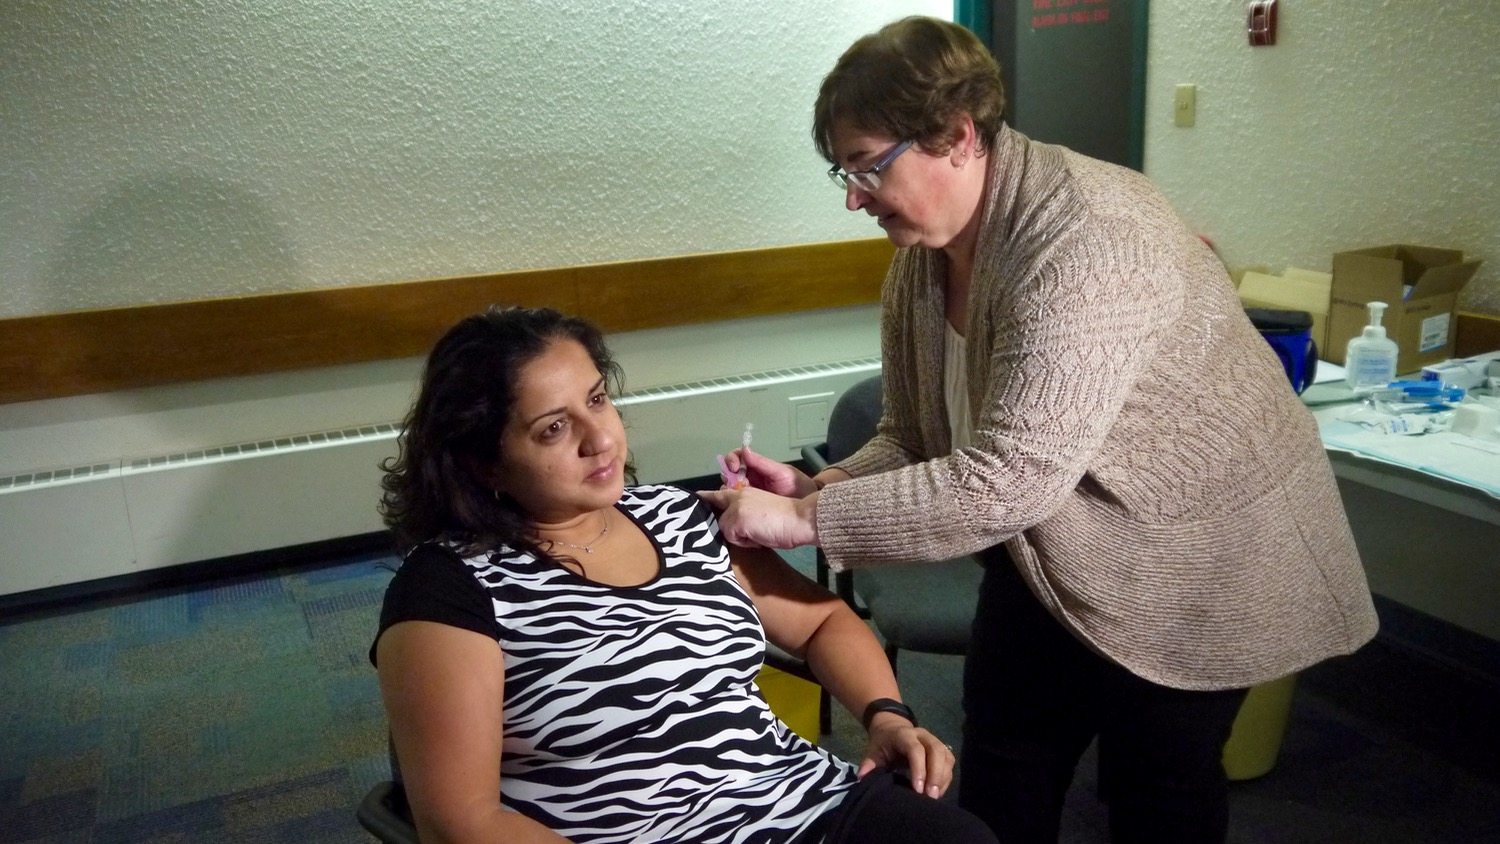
[377,621,506,826]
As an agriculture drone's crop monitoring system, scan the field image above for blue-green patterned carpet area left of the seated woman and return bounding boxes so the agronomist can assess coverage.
[0,555,395,843]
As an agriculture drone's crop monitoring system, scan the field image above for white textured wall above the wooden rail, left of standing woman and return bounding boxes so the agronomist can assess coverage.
[0,0,953,316]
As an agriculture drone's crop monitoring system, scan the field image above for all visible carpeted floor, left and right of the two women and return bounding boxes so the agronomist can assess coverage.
[0,553,1500,844]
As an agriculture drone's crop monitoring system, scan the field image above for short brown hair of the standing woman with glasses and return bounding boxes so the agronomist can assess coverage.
[813,15,1005,162]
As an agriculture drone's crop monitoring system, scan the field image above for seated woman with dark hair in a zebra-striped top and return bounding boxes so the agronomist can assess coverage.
[371,309,993,843]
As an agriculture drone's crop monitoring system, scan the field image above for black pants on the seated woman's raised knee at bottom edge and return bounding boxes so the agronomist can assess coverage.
[797,768,998,844]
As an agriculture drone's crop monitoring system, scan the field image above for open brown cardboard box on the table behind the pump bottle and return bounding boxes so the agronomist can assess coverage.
[1323,243,1481,375]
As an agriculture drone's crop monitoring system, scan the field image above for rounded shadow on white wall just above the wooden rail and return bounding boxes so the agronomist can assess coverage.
[39,172,302,313]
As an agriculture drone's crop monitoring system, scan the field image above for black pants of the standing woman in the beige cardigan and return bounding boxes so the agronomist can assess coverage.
[959,549,1247,844]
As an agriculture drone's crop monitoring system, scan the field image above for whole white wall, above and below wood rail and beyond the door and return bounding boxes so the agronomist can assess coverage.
[11,0,1500,488]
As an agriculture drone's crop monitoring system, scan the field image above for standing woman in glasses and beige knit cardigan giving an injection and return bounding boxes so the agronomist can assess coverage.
[704,18,1376,841]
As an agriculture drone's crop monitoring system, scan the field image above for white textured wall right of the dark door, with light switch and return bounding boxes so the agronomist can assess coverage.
[1146,0,1500,313]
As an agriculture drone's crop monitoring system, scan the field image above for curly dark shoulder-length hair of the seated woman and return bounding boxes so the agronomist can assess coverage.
[380,306,633,555]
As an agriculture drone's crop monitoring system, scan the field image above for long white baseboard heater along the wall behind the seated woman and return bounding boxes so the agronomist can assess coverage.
[0,358,881,595]
